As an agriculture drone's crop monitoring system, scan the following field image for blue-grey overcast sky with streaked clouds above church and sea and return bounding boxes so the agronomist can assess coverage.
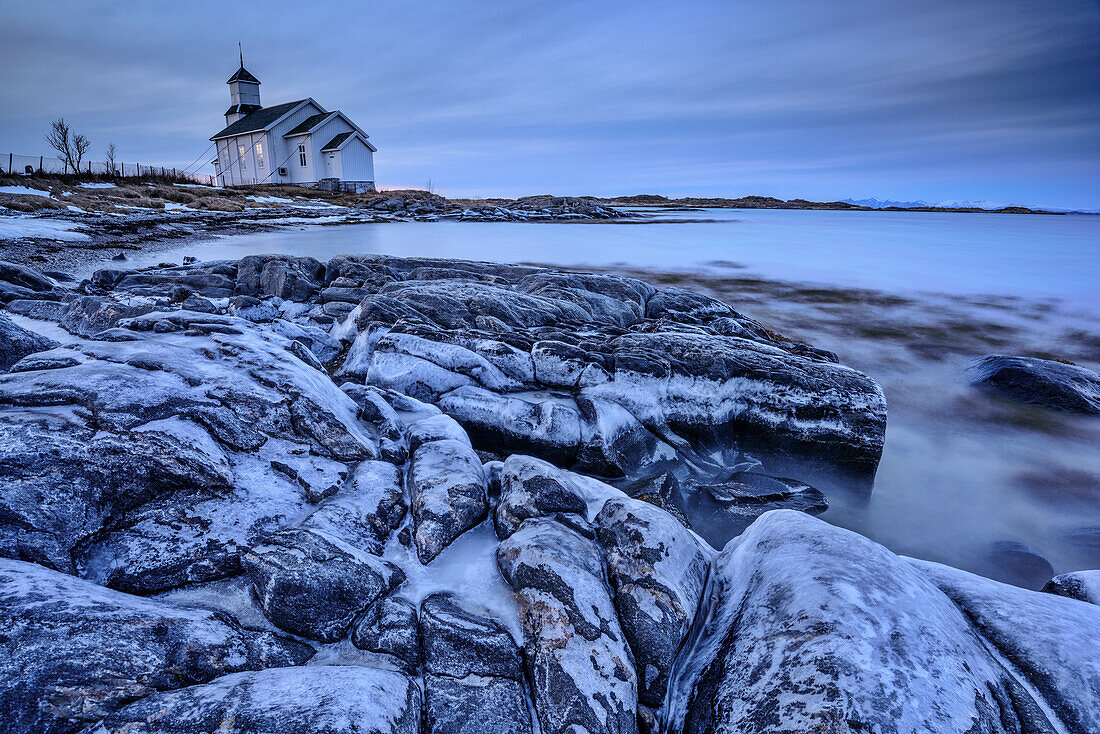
[0,0,1100,209]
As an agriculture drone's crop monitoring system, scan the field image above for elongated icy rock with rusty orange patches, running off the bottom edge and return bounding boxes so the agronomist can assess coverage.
[497,517,638,734]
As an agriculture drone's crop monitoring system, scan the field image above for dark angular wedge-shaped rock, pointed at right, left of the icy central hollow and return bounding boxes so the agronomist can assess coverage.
[243,529,405,642]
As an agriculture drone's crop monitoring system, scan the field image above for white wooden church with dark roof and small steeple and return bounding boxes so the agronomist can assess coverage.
[210,56,377,191]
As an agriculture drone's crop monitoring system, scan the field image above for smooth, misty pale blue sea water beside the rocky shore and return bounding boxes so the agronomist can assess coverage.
[138,210,1100,583]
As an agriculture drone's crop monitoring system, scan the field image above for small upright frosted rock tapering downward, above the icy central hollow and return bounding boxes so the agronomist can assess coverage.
[409,439,488,563]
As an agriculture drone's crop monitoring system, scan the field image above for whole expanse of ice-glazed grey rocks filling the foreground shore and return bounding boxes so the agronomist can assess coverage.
[0,250,1100,734]
